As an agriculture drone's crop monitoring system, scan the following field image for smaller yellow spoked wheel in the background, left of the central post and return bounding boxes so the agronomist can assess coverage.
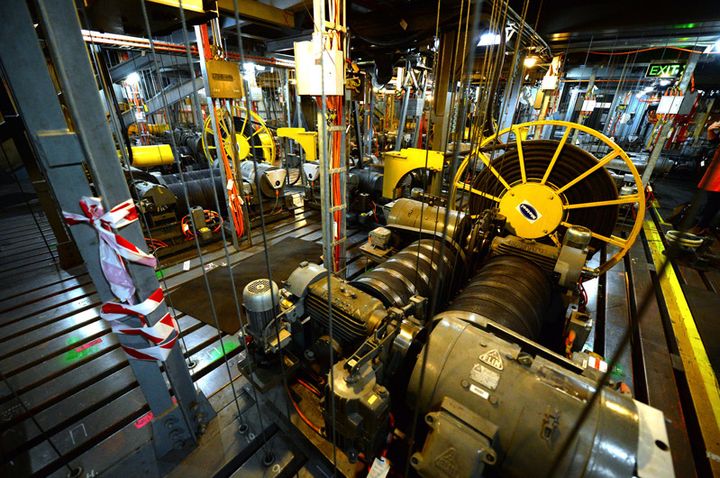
[202,108,276,163]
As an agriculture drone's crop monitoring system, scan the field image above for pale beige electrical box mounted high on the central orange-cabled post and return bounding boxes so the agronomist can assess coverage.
[295,33,345,96]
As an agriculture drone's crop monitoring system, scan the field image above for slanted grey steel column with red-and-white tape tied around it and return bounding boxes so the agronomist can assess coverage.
[0,0,214,464]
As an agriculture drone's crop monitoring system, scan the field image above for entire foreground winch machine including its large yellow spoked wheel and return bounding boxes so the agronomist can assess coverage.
[241,121,673,477]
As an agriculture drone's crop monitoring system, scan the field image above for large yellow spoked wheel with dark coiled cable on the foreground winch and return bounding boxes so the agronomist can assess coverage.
[449,121,645,274]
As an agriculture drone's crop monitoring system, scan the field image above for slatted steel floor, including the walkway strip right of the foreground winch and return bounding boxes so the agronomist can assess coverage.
[0,196,704,477]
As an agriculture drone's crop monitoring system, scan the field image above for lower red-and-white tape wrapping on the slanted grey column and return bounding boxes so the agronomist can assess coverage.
[100,287,180,361]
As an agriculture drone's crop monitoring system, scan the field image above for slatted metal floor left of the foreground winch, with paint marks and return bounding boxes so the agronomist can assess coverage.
[0,203,367,476]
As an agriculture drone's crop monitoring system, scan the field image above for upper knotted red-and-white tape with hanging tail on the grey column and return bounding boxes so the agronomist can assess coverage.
[63,196,157,302]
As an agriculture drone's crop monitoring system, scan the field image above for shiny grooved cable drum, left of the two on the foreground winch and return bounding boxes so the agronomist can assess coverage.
[352,239,465,307]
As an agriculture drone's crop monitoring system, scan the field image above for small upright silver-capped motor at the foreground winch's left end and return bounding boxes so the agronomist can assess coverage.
[243,279,280,343]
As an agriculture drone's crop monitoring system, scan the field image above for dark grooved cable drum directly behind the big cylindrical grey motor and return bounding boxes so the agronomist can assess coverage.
[442,255,552,340]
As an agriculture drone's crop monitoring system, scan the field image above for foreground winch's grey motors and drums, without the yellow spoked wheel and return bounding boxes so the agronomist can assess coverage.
[242,200,673,478]
